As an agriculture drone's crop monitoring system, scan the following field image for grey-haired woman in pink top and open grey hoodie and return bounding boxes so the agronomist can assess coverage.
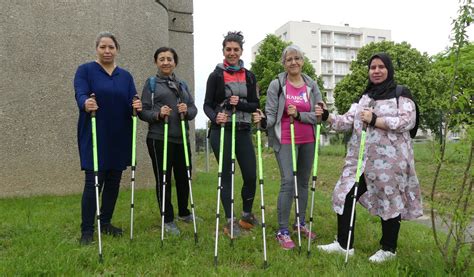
[254,45,322,250]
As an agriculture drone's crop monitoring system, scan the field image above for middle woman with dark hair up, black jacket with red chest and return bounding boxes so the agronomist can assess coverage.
[204,32,259,237]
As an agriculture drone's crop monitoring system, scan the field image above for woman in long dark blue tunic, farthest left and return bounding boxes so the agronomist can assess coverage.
[74,32,142,244]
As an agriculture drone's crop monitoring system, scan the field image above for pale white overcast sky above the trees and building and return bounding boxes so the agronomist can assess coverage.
[193,0,474,129]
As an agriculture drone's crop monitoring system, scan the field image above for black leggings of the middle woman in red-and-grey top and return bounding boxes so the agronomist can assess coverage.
[210,128,257,218]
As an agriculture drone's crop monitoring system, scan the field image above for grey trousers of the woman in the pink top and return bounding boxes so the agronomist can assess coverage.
[275,143,314,229]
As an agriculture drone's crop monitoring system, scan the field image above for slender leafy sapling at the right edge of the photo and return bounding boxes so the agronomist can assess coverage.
[430,0,474,275]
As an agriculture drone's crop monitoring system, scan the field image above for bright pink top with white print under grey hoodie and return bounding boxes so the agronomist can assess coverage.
[281,80,314,144]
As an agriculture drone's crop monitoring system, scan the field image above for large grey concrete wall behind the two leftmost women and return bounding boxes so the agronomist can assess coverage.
[0,0,194,197]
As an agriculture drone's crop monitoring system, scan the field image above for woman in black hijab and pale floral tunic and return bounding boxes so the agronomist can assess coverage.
[316,53,423,263]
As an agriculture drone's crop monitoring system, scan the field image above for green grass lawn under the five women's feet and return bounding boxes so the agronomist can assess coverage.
[0,142,474,276]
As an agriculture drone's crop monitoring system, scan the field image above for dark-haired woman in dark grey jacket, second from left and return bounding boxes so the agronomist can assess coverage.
[138,47,197,235]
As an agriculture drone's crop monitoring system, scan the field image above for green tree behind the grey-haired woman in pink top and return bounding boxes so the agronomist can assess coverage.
[251,34,323,110]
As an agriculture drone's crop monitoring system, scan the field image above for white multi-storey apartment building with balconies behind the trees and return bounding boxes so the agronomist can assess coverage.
[252,21,391,104]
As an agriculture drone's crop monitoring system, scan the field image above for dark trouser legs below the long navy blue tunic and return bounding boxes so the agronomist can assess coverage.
[81,170,122,233]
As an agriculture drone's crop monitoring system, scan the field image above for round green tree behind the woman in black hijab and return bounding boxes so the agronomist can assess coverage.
[335,41,443,136]
